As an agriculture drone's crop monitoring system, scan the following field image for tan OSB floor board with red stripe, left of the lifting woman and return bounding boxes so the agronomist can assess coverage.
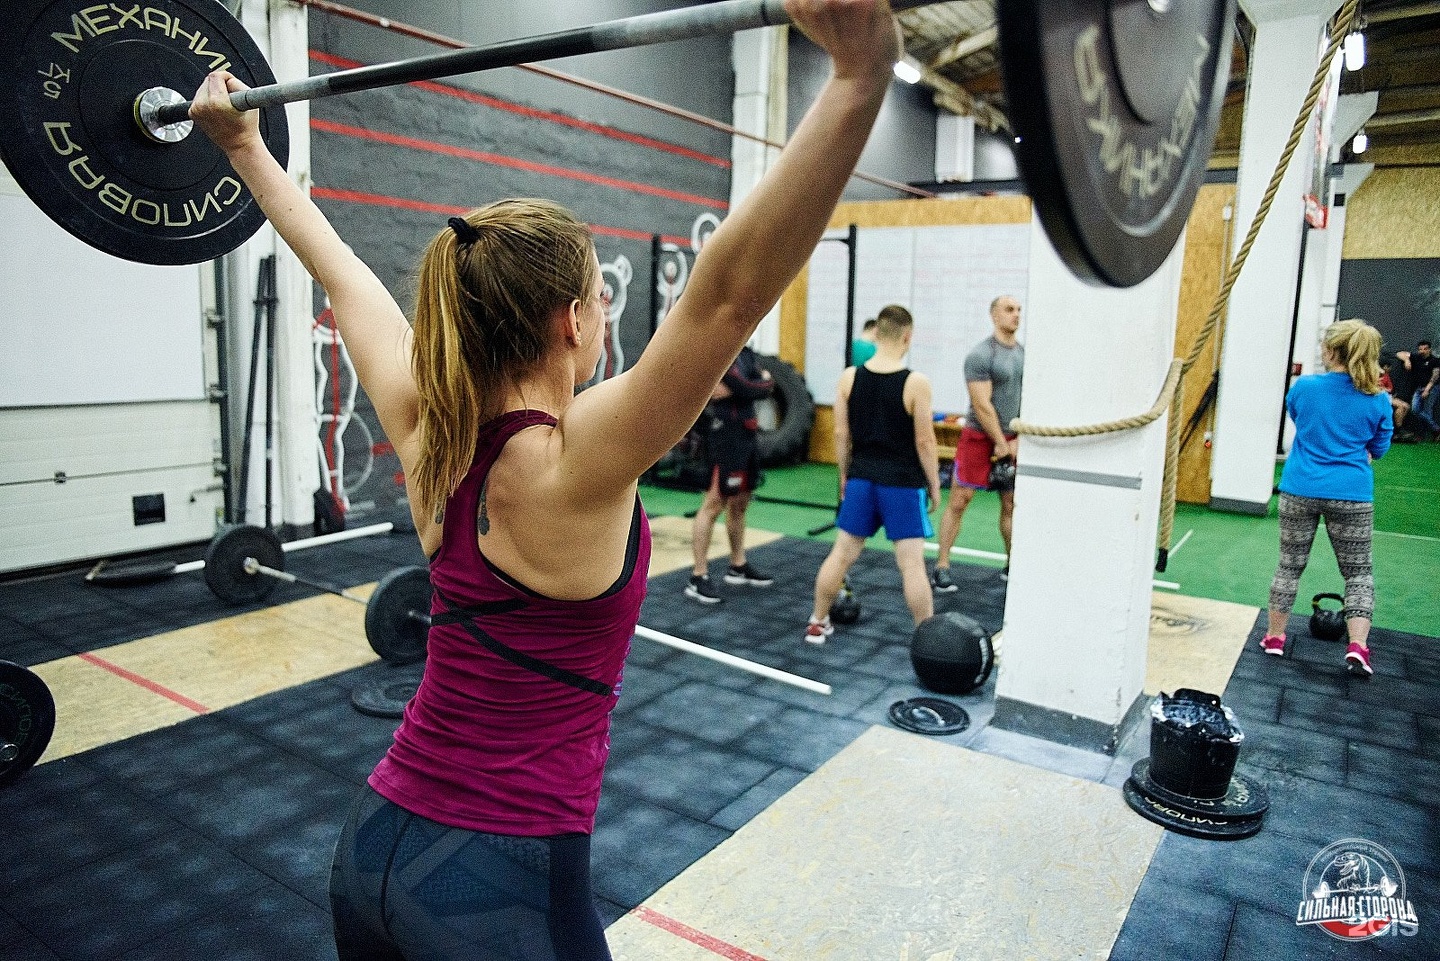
[32,585,377,762]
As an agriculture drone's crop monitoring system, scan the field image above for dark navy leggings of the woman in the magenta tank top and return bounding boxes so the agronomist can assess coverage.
[330,788,611,961]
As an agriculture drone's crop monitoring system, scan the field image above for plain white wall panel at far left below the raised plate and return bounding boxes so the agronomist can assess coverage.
[0,184,206,408]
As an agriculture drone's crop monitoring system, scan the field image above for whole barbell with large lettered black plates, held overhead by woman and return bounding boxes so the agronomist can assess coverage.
[0,0,1236,287]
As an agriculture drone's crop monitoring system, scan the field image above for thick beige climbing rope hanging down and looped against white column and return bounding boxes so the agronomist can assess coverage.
[1009,0,1359,571]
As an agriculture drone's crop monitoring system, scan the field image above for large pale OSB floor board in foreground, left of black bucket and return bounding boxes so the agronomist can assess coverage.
[608,726,1162,961]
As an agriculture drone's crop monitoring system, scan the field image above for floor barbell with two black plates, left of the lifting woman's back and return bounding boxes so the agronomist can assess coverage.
[204,526,431,664]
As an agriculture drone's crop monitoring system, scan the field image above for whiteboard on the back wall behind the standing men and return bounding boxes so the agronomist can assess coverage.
[805,223,1031,414]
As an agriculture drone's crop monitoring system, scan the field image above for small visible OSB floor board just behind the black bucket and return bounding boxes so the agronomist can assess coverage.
[1145,591,1260,694]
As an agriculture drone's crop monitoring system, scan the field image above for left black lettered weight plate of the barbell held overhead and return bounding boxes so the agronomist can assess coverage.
[0,0,289,263]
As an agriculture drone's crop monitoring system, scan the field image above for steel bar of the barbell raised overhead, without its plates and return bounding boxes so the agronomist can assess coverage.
[145,0,939,127]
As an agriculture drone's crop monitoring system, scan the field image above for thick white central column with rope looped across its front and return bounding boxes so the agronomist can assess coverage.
[991,226,1184,751]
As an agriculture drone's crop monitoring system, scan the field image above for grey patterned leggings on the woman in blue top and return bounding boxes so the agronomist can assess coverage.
[1270,493,1375,620]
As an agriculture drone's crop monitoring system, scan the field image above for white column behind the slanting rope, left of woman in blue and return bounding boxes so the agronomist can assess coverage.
[1210,0,1339,514]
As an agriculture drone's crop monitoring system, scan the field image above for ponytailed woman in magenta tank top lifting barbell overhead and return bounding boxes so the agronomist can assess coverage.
[192,0,899,961]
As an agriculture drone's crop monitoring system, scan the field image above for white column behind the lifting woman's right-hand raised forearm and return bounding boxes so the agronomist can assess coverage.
[730,26,789,354]
